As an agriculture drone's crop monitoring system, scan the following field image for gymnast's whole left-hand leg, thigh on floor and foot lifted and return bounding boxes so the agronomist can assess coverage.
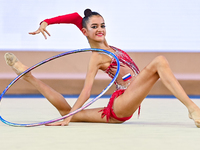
[5,53,121,123]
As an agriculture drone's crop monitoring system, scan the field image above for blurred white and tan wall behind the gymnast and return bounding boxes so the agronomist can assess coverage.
[0,0,200,95]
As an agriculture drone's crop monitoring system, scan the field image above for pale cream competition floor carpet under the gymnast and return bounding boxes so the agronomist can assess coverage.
[0,96,200,150]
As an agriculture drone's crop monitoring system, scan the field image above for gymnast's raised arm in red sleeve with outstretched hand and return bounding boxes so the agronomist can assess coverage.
[29,12,82,39]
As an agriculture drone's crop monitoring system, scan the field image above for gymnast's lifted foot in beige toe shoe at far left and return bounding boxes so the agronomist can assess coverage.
[4,53,29,76]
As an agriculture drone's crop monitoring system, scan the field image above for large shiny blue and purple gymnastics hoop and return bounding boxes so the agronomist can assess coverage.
[0,48,120,127]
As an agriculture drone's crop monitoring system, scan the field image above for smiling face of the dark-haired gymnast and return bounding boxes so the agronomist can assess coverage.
[83,15,106,42]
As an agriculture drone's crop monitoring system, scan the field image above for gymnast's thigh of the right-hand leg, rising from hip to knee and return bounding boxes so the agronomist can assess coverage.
[113,70,158,118]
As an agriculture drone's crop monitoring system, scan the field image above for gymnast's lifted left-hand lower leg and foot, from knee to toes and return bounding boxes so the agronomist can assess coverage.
[4,53,71,115]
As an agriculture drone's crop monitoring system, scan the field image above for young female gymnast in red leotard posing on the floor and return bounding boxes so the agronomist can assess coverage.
[5,9,200,127]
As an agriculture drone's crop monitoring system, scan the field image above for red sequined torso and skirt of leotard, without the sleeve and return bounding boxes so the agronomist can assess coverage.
[100,46,140,121]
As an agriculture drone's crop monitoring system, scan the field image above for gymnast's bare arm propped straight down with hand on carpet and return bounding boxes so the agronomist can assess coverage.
[48,52,102,126]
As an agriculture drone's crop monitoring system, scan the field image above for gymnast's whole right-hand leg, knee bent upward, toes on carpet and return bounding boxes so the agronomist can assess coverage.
[114,56,200,127]
